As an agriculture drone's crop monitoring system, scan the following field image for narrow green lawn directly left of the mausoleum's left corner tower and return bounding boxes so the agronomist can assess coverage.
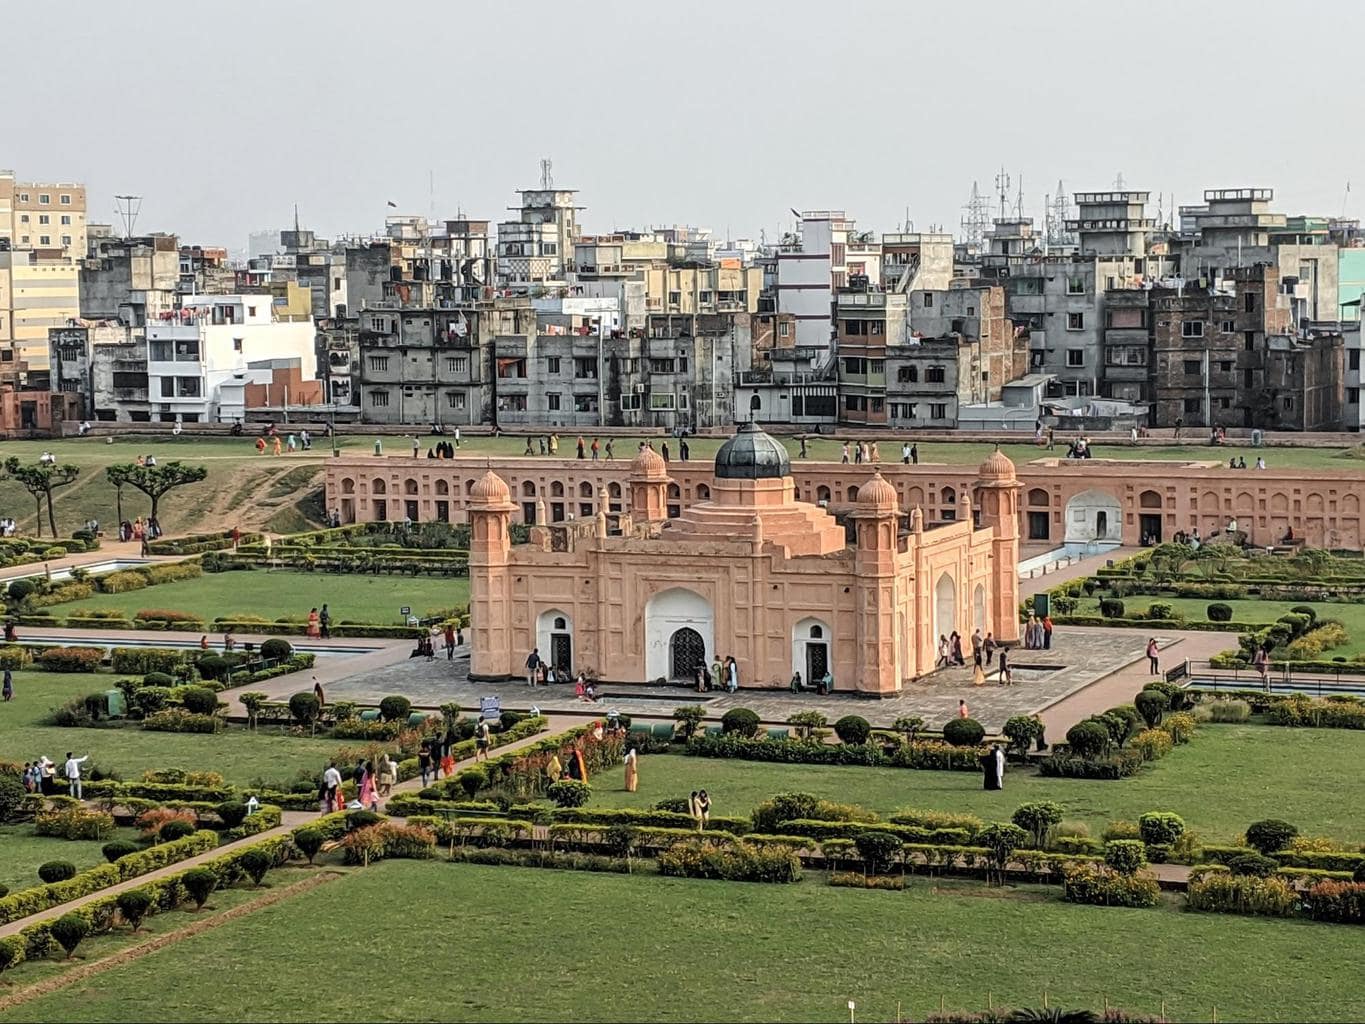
[45,569,470,632]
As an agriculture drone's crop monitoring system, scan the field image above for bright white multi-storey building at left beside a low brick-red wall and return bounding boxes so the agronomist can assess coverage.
[147,295,317,423]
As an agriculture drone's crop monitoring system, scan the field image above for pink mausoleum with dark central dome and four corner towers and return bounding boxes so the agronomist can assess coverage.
[467,425,1021,696]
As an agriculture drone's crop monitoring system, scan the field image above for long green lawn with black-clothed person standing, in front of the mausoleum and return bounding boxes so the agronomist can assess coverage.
[592,725,1365,842]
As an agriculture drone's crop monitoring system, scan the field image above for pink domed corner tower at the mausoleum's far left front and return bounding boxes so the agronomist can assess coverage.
[470,470,516,679]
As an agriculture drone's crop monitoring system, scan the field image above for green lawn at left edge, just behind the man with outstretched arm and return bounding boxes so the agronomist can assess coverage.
[0,672,341,791]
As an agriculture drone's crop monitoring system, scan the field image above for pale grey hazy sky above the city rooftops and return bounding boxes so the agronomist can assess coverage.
[13,0,1365,248]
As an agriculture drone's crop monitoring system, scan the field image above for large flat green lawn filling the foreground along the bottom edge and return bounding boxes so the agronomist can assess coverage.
[5,862,1365,1024]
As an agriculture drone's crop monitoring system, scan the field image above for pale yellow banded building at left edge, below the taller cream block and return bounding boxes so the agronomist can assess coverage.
[0,251,81,370]
